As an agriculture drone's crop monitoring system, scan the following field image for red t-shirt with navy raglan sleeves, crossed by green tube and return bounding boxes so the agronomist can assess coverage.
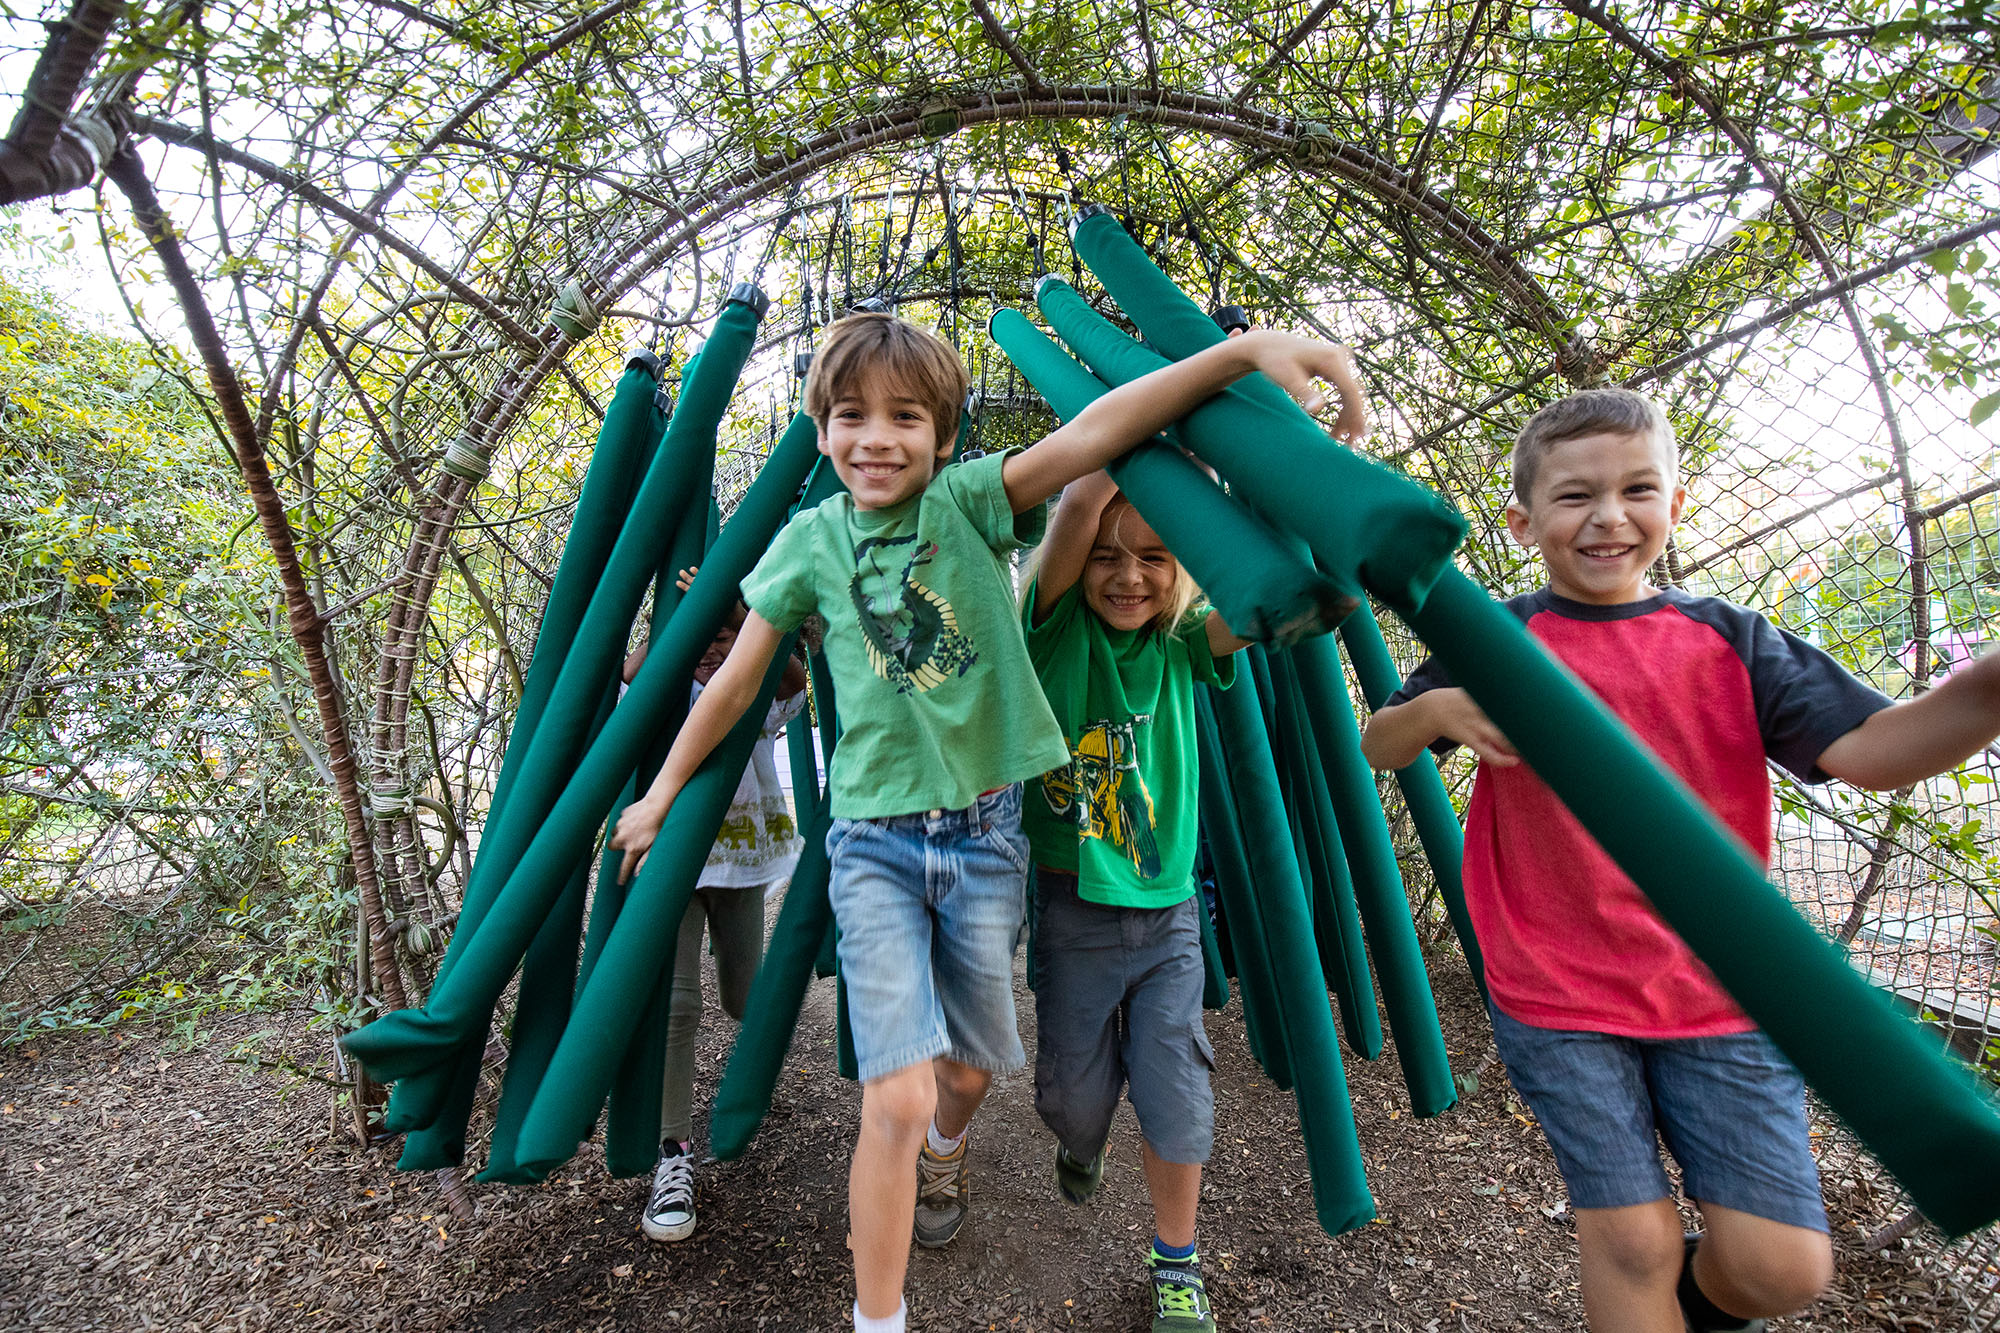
[1388,588,1890,1037]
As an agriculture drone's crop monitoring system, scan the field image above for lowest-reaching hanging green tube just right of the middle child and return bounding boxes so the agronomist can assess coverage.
[1210,679,1376,1235]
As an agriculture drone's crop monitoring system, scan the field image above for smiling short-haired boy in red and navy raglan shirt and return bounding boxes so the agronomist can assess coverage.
[1362,388,2000,1333]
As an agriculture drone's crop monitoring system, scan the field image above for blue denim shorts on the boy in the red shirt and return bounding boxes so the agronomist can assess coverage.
[1488,1009,1826,1231]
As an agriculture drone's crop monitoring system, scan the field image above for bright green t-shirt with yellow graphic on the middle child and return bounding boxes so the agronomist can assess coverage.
[1020,584,1236,907]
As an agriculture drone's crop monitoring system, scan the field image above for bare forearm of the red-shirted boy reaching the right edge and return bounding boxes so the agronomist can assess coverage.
[1820,652,2000,791]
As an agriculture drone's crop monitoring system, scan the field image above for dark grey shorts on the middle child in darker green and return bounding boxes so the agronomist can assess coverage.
[1034,871,1216,1163]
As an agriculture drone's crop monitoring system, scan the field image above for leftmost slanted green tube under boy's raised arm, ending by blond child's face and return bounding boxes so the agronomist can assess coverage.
[990,312,1358,642]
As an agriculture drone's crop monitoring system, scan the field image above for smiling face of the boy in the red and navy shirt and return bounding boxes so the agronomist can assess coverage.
[1506,430,1688,606]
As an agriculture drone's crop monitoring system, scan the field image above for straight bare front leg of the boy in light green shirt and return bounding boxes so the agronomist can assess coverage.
[848,1065,932,1319]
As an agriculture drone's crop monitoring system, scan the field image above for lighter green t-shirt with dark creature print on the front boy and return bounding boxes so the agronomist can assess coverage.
[744,454,1068,819]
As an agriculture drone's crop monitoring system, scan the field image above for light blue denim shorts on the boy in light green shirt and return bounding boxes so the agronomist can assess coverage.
[826,783,1028,1083]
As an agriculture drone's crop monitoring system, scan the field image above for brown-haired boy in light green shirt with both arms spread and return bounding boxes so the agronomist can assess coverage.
[612,314,1352,1333]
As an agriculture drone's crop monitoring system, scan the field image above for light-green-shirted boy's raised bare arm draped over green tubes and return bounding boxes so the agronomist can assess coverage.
[1000,328,1366,514]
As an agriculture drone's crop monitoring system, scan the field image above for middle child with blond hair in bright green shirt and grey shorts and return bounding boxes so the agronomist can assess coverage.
[1022,472,1272,1333]
